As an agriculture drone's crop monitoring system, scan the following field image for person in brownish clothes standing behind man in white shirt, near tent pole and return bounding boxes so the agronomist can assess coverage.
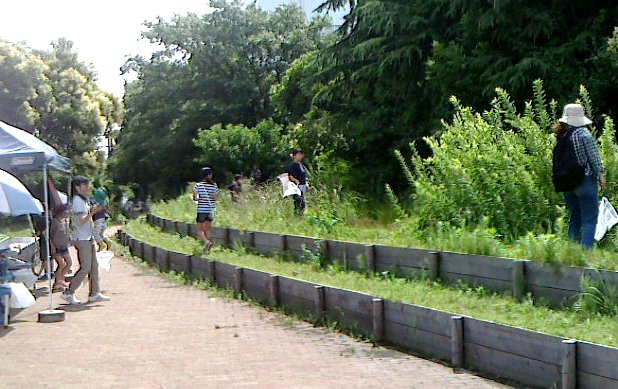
[49,204,73,292]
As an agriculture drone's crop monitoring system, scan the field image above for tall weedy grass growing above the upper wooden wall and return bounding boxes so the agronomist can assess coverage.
[151,184,618,270]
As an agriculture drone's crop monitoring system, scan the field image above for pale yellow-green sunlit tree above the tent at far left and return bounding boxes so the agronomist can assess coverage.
[0,39,123,175]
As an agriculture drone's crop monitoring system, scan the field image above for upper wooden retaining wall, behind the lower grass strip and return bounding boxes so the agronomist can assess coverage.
[148,214,618,304]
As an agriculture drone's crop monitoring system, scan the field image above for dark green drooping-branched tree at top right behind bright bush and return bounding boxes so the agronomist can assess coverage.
[299,0,618,193]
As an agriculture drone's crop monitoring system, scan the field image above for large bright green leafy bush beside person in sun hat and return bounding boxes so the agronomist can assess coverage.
[404,81,618,239]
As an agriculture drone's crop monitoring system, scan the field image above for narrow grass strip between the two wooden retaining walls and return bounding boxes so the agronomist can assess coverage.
[125,220,618,347]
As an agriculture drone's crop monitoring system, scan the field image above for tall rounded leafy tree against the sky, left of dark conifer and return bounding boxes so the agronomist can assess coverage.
[111,0,327,198]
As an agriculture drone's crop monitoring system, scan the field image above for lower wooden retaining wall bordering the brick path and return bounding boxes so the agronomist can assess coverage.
[119,227,618,389]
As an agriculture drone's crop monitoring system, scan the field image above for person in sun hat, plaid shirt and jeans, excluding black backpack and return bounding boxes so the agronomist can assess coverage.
[554,104,607,249]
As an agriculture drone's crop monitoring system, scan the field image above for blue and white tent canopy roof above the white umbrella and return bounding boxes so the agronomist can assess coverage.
[0,121,71,173]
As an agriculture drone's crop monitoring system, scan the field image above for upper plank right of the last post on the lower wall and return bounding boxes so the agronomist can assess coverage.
[577,342,618,378]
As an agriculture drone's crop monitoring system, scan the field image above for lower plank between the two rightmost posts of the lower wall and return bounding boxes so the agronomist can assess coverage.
[464,342,561,388]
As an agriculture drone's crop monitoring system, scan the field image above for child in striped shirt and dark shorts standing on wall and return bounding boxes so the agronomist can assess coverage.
[193,167,219,252]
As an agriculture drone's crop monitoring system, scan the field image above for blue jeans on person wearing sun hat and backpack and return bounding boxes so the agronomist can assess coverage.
[564,175,599,249]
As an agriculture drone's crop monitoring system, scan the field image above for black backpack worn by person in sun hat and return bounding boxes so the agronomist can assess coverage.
[551,127,586,192]
